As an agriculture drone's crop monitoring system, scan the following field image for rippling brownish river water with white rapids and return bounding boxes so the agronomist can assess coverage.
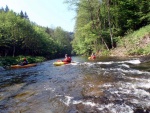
[0,57,150,113]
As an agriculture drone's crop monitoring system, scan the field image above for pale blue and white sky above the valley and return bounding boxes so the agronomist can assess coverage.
[0,0,76,32]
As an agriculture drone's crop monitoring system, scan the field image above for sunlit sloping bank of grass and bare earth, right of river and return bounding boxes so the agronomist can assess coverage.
[110,25,150,56]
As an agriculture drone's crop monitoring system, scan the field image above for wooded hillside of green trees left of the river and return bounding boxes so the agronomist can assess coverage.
[0,6,73,59]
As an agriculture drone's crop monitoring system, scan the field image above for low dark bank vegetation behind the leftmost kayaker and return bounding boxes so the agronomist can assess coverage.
[0,56,46,67]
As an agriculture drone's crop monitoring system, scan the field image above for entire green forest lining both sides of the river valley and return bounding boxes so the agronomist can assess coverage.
[0,0,150,59]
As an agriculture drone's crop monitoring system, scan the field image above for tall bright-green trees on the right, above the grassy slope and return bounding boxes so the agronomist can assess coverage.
[66,0,150,55]
